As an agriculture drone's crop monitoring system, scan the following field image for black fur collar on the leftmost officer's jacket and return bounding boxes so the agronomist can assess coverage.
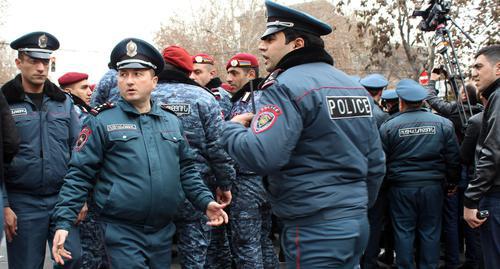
[2,74,66,104]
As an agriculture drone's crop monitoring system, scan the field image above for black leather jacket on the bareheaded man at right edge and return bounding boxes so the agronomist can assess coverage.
[464,79,500,208]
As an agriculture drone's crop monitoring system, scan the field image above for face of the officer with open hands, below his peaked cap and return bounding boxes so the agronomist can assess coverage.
[118,69,158,106]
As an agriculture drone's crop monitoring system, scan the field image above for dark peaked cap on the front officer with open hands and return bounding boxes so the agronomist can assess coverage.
[110,38,165,75]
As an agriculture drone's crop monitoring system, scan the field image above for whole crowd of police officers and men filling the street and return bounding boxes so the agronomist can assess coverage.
[0,0,500,269]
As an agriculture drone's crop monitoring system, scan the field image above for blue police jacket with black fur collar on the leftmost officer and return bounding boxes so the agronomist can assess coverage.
[2,75,80,195]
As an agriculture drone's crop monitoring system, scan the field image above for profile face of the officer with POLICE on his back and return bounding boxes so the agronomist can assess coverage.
[259,32,297,72]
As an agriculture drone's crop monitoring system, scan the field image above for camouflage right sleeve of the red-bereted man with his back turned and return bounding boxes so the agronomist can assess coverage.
[200,99,236,188]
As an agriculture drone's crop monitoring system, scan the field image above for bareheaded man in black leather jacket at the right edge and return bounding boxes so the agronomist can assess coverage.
[464,45,500,268]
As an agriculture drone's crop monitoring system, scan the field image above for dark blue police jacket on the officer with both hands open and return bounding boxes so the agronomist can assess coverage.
[54,99,213,229]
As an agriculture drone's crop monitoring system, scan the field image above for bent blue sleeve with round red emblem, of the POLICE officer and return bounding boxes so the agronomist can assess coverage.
[222,84,303,175]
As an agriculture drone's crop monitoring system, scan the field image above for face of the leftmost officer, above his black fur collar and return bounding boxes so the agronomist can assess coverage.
[16,54,50,86]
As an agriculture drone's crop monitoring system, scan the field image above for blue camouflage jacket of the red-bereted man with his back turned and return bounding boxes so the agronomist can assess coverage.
[152,70,236,187]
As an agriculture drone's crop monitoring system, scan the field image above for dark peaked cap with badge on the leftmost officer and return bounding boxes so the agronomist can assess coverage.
[10,32,59,60]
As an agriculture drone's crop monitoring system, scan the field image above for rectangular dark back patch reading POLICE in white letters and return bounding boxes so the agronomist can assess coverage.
[326,96,372,120]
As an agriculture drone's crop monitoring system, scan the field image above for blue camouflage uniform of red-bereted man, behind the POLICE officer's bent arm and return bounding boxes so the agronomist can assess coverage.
[229,79,279,269]
